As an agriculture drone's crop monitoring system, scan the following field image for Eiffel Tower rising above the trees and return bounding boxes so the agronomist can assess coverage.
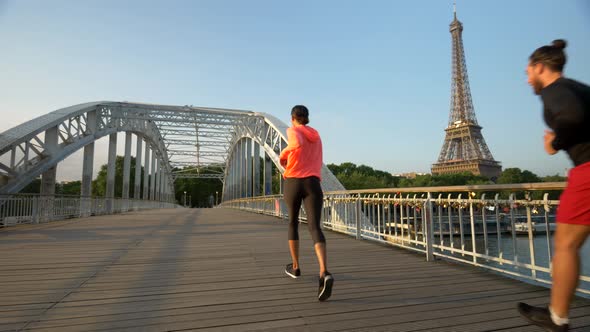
[432,5,502,179]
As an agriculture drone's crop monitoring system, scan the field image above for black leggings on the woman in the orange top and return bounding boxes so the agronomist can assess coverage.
[283,176,326,244]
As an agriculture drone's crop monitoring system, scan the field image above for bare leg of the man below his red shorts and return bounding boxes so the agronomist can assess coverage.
[551,223,590,318]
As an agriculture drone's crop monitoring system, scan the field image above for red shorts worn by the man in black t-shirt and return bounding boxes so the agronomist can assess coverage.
[557,162,590,226]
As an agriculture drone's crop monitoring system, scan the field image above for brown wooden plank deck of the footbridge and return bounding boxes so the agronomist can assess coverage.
[0,209,590,331]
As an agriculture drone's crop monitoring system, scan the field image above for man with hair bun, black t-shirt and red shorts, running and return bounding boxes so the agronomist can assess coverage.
[518,39,590,331]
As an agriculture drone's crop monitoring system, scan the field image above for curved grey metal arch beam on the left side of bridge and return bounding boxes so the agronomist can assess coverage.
[0,102,171,194]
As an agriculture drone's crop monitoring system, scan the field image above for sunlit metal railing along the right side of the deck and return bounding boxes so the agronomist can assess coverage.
[222,182,590,296]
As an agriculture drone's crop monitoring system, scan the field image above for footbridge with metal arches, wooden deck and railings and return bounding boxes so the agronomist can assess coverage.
[0,101,590,331]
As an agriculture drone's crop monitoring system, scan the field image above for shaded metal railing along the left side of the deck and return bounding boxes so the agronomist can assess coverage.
[0,194,179,227]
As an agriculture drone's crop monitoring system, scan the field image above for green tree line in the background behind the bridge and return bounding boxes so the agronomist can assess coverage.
[21,156,566,202]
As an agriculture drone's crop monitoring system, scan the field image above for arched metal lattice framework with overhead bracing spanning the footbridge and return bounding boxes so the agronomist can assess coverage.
[0,101,343,194]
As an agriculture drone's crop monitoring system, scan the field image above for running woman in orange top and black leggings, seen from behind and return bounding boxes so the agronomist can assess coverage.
[280,105,334,301]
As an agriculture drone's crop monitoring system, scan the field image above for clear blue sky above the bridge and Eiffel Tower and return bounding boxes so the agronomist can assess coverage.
[0,0,590,179]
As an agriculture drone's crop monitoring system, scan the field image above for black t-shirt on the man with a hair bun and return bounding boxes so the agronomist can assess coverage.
[541,77,590,166]
